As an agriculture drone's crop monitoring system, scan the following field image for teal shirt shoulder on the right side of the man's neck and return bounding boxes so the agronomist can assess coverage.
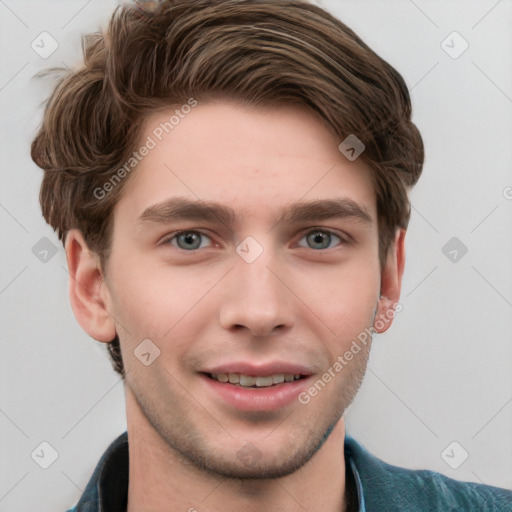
[345,436,512,512]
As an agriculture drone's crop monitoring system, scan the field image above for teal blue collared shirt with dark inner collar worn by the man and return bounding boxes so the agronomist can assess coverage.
[67,432,512,512]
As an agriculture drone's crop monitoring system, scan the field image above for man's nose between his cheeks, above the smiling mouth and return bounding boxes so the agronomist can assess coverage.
[219,247,294,337]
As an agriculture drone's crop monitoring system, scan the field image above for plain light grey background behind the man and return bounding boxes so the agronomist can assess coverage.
[0,0,512,512]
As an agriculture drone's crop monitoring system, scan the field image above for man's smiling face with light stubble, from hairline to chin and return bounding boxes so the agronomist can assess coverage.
[105,102,381,477]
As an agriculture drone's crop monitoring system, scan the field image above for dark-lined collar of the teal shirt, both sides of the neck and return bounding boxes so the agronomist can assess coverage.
[73,432,366,512]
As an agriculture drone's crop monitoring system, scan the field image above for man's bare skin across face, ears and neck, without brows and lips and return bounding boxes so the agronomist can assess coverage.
[65,101,405,512]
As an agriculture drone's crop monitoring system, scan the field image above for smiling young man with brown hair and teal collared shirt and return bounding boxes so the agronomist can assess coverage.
[32,0,512,512]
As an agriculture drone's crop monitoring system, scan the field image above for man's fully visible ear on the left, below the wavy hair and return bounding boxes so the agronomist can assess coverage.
[65,229,116,342]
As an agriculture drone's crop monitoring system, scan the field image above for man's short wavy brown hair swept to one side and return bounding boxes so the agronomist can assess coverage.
[31,0,424,377]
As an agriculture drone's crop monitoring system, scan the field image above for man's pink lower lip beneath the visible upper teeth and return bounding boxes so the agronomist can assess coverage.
[200,374,309,411]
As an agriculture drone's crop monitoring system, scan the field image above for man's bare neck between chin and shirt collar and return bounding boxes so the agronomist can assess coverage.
[126,390,346,512]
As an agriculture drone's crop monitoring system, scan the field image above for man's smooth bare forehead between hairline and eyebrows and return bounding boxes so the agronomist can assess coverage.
[114,101,376,222]
